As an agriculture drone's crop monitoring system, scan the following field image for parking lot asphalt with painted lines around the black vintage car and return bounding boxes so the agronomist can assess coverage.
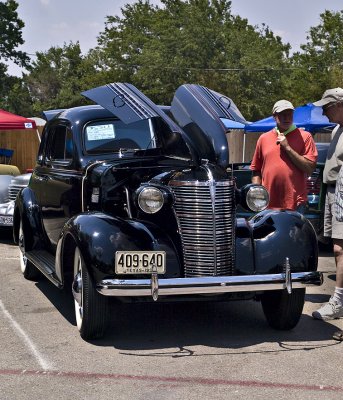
[0,231,343,400]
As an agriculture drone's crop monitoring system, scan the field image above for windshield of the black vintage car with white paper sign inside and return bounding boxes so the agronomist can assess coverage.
[84,120,156,154]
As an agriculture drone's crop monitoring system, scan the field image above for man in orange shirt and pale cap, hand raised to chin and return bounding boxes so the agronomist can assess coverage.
[250,100,318,213]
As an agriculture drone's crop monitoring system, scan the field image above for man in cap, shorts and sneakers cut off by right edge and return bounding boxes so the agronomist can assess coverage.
[312,88,343,332]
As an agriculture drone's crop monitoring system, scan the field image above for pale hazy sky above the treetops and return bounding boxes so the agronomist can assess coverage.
[2,0,343,76]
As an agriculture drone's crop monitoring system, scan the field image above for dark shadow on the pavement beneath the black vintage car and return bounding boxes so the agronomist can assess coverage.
[31,279,339,357]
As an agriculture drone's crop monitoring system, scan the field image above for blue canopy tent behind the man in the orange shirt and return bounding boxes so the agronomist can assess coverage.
[243,103,335,161]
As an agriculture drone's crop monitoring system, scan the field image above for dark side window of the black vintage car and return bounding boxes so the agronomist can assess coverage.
[48,125,73,161]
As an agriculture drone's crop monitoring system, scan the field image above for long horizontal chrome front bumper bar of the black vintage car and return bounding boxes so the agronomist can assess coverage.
[96,271,323,297]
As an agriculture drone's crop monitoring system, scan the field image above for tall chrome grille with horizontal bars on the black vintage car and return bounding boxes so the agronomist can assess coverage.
[169,180,235,277]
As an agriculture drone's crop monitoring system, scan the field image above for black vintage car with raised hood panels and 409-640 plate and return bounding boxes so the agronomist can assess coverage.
[14,83,322,339]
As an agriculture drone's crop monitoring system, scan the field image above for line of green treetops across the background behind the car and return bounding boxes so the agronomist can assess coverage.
[0,0,343,121]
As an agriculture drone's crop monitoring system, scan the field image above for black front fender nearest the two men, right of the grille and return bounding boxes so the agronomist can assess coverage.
[248,210,318,274]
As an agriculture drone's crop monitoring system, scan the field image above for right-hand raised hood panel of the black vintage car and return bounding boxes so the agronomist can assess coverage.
[170,84,245,167]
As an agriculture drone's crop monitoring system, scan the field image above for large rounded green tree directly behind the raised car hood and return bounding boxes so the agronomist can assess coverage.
[96,0,290,119]
